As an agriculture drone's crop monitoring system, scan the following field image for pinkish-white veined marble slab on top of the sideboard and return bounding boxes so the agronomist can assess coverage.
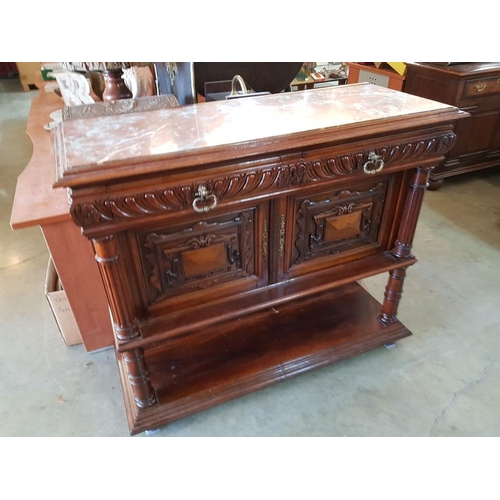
[56,84,452,172]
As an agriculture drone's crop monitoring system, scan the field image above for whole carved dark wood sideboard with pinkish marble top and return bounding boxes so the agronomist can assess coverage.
[54,84,466,434]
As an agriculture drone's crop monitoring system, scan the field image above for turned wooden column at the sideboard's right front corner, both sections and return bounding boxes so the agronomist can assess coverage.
[379,167,431,323]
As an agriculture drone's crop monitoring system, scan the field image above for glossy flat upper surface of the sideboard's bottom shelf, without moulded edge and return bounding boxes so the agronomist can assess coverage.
[146,284,402,402]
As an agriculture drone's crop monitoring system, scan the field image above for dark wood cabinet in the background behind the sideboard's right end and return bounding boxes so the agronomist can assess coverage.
[405,63,500,189]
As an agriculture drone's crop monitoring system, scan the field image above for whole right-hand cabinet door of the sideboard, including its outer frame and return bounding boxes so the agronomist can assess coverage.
[288,177,395,276]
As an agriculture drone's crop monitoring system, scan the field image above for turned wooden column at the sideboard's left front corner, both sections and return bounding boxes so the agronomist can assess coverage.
[92,235,156,408]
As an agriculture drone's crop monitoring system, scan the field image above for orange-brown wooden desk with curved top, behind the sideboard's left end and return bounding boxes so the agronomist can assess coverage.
[11,77,113,352]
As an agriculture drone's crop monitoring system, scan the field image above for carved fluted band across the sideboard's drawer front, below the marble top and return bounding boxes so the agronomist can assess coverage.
[71,133,456,227]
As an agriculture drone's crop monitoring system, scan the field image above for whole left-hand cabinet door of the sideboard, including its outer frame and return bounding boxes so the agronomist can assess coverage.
[133,202,268,311]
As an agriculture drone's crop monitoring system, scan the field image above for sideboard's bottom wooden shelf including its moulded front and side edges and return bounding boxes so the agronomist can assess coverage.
[117,283,411,434]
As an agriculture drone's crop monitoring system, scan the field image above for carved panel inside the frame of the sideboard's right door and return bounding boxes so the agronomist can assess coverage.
[291,180,387,267]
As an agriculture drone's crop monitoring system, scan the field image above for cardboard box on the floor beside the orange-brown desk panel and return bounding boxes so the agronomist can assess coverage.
[45,258,82,346]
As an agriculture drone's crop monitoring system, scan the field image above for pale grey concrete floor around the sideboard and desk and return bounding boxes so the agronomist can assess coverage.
[0,75,500,437]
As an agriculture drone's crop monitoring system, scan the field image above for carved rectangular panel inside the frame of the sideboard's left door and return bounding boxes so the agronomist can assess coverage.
[136,208,267,305]
